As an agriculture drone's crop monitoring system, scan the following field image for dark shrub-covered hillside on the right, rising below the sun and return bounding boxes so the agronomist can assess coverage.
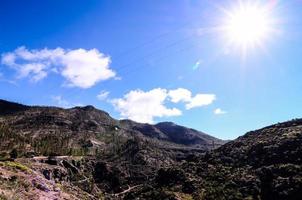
[129,119,302,200]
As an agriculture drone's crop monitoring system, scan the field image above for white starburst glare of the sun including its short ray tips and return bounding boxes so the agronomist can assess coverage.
[219,1,277,57]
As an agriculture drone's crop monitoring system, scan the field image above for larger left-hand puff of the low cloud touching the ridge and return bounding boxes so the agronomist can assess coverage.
[111,88,182,123]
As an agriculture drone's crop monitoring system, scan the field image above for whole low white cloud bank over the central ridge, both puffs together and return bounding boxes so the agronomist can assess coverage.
[111,88,216,123]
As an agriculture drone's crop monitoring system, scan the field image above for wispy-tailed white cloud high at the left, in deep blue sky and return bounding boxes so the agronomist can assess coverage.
[1,47,115,88]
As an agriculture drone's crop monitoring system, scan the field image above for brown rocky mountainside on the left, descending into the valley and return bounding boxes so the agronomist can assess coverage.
[0,100,225,199]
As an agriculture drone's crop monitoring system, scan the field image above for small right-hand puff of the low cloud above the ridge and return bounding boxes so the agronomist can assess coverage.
[168,88,216,110]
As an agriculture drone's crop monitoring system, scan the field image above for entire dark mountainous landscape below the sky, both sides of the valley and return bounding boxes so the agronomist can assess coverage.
[0,101,302,200]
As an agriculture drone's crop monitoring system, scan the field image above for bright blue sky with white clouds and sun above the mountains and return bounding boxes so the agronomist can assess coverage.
[0,0,302,139]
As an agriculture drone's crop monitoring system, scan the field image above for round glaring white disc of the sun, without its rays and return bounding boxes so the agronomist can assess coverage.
[224,2,273,51]
